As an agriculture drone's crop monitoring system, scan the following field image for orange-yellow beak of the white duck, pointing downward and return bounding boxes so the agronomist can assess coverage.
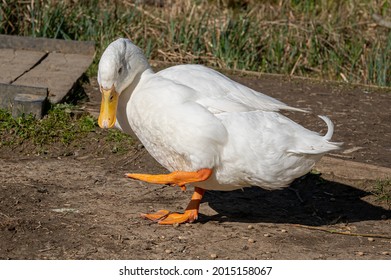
[98,85,119,128]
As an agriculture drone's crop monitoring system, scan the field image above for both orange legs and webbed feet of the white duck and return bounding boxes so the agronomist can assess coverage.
[126,168,212,225]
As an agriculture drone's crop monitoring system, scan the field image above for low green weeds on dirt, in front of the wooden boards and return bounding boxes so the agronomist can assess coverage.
[0,104,134,153]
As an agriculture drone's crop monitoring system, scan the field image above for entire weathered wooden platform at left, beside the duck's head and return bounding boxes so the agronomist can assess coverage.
[0,35,95,117]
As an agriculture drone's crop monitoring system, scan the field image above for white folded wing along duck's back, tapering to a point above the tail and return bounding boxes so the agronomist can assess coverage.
[158,65,307,113]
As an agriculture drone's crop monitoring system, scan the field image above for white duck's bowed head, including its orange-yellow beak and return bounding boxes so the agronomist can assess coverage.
[98,38,150,128]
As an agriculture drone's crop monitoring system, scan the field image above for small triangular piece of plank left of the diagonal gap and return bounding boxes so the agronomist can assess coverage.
[0,49,46,84]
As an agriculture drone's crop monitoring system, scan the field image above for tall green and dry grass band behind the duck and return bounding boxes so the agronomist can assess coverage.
[0,0,391,86]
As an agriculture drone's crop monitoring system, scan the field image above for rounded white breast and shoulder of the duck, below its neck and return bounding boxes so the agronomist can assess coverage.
[128,76,228,171]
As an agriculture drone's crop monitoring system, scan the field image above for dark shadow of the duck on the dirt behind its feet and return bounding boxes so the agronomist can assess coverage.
[199,174,391,226]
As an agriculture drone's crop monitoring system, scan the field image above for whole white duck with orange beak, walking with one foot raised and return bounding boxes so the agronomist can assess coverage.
[98,39,340,224]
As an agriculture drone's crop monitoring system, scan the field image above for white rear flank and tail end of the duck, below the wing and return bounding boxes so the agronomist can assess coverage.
[198,111,339,190]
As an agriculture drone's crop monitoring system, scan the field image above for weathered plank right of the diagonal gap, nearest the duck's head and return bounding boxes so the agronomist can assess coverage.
[14,53,93,103]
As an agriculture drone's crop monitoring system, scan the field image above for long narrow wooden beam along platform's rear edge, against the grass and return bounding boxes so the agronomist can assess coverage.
[0,34,95,56]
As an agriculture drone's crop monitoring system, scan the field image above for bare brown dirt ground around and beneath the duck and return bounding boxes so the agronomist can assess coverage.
[0,67,391,259]
